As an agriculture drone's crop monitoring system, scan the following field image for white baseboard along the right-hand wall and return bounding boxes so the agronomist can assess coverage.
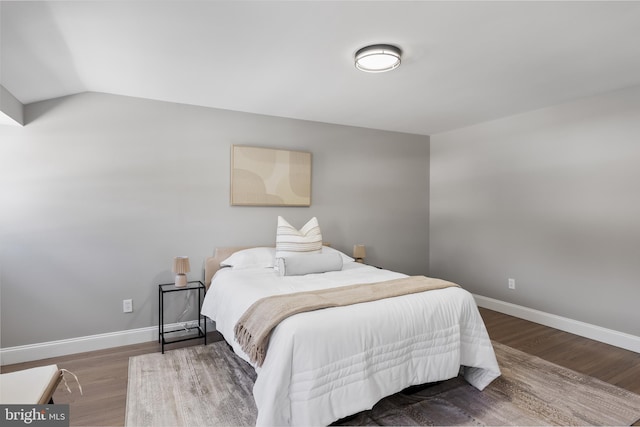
[473,295,640,353]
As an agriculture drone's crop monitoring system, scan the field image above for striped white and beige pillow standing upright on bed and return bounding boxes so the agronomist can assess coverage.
[276,216,322,258]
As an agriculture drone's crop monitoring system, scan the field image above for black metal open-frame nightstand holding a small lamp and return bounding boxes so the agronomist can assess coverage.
[158,280,207,354]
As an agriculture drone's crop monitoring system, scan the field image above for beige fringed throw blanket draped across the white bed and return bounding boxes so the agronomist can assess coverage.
[234,276,458,366]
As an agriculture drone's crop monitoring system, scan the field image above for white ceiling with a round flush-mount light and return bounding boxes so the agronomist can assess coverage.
[0,0,640,135]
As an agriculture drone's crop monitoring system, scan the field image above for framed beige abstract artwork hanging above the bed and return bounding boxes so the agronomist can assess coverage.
[231,145,311,206]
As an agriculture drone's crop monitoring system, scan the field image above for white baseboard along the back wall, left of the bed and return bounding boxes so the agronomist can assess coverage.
[0,320,215,365]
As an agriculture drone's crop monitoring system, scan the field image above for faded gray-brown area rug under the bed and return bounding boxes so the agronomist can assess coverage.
[125,342,640,427]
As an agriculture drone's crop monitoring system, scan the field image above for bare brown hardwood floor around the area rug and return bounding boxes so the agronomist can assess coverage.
[1,309,640,426]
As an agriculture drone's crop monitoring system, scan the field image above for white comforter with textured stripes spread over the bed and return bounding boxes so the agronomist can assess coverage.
[202,262,500,425]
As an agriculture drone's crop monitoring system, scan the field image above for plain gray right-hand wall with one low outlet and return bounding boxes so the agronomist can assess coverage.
[429,88,640,336]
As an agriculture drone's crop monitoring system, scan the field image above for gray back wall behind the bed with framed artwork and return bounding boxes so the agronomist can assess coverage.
[0,93,429,347]
